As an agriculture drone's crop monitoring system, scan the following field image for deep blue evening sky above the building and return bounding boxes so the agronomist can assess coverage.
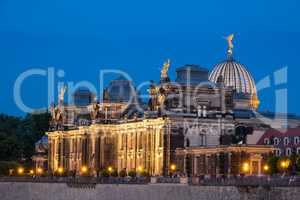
[0,0,300,115]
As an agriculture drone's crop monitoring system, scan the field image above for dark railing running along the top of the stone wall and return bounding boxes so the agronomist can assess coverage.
[0,176,300,187]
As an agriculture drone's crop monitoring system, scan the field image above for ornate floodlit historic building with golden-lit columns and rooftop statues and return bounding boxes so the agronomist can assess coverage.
[47,36,272,175]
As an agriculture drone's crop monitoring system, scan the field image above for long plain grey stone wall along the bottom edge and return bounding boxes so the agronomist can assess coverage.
[0,182,300,200]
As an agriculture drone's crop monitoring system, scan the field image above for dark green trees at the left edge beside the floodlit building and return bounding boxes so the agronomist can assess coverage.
[0,112,50,173]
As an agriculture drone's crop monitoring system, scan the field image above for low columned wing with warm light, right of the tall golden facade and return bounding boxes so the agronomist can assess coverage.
[176,145,274,177]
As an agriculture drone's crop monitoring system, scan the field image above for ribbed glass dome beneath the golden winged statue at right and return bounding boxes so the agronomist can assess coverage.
[209,57,256,95]
